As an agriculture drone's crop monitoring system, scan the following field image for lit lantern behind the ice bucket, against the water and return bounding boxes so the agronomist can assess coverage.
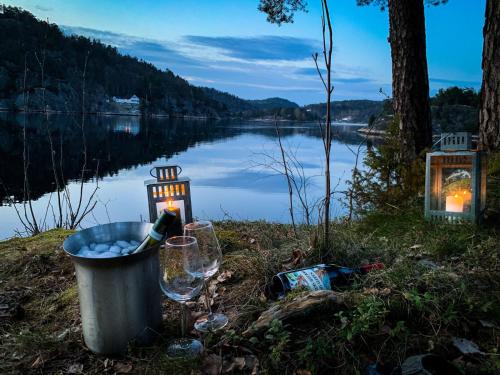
[144,165,193,226]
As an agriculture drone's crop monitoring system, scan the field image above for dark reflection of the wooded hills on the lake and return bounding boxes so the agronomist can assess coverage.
[0,115,359,202]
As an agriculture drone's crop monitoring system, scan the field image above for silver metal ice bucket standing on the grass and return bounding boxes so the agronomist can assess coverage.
[63,222,161,354]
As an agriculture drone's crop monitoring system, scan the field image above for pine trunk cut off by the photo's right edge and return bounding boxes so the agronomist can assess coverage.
[479,0,500,151]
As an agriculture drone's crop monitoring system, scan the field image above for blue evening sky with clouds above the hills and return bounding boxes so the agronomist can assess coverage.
[0,0,486,105]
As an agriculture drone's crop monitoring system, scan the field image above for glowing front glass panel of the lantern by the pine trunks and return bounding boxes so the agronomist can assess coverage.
[430,156,472,213]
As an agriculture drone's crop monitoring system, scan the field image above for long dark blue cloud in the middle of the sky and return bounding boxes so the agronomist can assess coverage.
[184,35,320,60]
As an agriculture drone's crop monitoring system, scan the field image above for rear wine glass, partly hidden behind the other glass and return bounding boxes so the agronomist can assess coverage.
[184,220,228,332]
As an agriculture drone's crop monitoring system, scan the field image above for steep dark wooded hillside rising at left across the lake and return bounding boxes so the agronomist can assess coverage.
[0,7,236,116]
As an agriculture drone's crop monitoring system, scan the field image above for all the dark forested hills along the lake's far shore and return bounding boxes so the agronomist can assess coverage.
[0,7,479,126]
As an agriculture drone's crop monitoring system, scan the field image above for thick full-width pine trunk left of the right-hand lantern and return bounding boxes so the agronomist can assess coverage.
[389,0,432,163]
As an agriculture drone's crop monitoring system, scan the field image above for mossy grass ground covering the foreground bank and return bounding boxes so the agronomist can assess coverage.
[0,207,500,374]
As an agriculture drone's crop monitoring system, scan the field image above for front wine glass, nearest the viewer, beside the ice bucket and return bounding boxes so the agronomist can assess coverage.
[160,236,204,357]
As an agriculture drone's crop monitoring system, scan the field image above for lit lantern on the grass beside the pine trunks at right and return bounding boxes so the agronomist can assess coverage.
[425,132,486,223]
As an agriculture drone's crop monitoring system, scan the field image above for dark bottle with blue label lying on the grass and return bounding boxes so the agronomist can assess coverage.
[268,263,384,298]
